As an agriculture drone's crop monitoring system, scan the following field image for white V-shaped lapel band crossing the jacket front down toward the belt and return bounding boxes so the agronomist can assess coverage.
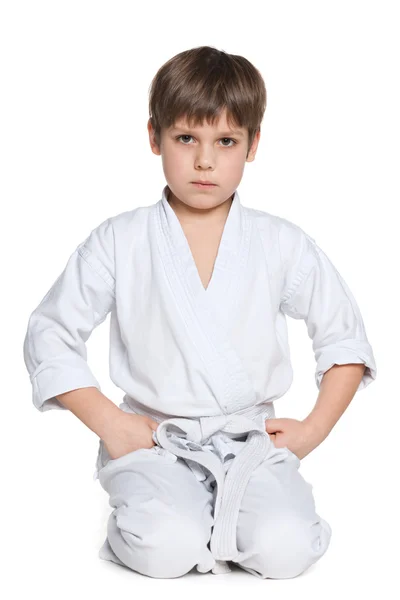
[155,186,256,413]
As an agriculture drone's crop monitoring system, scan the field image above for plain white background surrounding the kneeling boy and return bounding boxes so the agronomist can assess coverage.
[0,0,400,600]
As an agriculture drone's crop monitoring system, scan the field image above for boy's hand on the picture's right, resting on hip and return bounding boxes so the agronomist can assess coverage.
[265,418,325,460]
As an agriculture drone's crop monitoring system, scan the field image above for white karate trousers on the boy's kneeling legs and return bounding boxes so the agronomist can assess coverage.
[98,432,332,579]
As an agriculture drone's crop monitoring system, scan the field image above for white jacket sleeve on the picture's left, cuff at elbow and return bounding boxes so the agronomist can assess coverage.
[23,219,115,412]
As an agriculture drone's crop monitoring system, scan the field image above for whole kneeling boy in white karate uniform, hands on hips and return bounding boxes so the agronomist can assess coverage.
[24,46,376,578]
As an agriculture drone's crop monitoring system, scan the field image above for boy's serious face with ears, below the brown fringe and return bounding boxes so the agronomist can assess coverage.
[147,111,260,209]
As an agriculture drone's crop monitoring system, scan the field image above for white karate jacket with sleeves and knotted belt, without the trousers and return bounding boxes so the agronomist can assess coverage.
[24,186,377,580]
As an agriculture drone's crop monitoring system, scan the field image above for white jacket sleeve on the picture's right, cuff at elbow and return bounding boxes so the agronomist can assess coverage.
[280,227,377,391]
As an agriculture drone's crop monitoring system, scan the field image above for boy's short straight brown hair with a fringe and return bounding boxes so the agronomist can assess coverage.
[149,46,267,157]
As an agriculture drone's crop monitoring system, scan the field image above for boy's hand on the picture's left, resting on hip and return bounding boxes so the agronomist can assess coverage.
[102,411,158,459]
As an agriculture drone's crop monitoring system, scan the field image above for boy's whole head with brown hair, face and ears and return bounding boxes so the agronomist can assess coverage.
[147,46,267,209]
